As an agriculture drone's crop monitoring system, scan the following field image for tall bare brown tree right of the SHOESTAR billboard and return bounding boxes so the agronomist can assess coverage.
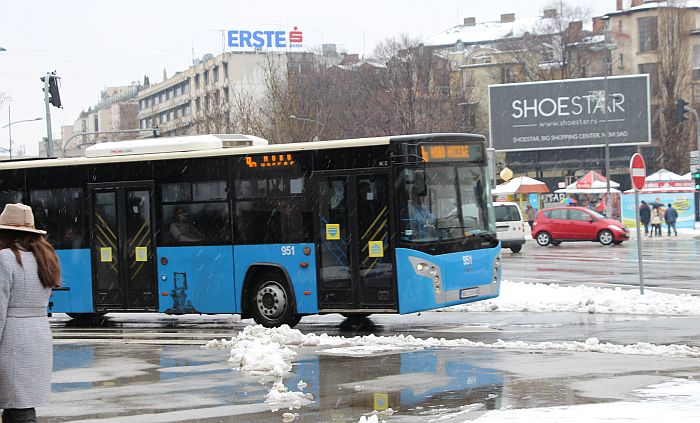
[658,0,695,171]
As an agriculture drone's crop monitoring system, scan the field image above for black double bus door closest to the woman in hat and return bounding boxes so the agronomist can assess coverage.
[90,182,158,311]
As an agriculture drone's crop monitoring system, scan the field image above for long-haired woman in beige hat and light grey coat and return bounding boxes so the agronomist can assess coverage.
[0,204,61,423]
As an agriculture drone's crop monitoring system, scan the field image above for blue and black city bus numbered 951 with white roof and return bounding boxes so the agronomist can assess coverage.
[0,134,500,327]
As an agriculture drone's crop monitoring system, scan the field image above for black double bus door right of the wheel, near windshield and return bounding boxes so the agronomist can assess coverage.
[313,170,397,312]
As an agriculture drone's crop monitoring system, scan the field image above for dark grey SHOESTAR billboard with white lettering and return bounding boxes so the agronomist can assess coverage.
[489,75,651,151]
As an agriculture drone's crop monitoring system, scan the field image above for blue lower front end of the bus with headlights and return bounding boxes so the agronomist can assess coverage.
[396,243,501,314]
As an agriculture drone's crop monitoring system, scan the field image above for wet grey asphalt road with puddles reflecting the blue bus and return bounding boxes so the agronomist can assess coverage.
[39,238,700,423]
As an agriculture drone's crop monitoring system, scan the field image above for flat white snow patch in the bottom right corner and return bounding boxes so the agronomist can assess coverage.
[475,379,700,423]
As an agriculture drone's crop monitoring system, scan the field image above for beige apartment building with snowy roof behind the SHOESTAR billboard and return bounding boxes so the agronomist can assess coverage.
[428,0,700,188]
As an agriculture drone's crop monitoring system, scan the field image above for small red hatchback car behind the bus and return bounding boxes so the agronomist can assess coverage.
[532,206,629,247]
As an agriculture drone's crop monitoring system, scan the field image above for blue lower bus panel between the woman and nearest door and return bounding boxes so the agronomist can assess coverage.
[48,249,94,313]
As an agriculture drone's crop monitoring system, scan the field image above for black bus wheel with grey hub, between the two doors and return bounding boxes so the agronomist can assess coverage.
[251,272,301,328]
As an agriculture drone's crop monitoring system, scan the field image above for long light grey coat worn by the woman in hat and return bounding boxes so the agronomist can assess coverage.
[0,248,53,409]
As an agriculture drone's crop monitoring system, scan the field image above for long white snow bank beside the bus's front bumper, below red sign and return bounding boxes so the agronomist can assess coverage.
[443,281,700,316]
